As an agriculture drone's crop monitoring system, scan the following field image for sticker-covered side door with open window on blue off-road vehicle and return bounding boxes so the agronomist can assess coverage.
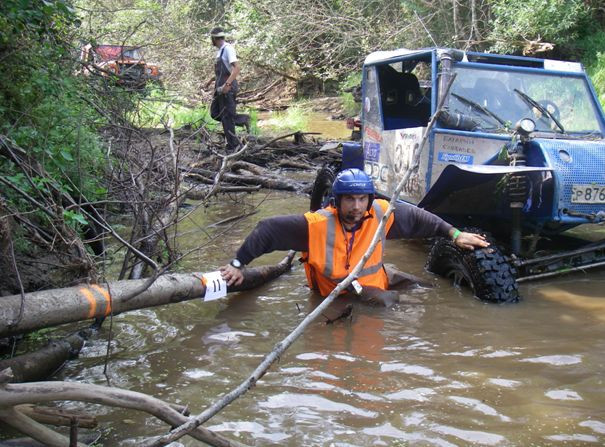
[362,51,436,203]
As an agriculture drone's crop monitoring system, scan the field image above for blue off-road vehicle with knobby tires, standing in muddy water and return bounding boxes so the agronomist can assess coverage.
[311,49,605,302]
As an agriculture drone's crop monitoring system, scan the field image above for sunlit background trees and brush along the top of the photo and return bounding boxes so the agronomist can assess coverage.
[66,0,603,101]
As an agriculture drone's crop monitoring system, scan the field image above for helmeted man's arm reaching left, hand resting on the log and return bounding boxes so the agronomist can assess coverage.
[220,215,309,286]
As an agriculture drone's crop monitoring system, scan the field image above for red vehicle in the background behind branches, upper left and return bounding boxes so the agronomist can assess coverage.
[80,44,160,87]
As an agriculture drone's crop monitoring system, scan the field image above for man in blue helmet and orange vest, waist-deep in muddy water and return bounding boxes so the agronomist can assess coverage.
[220,168,489,305]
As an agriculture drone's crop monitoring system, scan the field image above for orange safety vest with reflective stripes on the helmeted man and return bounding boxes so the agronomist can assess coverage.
[302,199,395,296]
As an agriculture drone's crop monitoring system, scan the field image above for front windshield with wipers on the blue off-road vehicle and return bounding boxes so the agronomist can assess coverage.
[448,66,601,134]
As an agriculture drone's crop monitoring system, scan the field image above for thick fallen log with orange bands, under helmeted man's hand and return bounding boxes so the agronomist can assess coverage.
[0,252,294,337]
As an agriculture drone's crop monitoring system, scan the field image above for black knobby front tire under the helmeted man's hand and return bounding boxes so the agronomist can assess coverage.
[426,233,520,303]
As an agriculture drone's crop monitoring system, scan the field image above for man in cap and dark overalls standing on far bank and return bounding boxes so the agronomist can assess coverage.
[210,27,240,152]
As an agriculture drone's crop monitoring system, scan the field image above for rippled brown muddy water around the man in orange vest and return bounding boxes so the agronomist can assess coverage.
[66,194,605,446]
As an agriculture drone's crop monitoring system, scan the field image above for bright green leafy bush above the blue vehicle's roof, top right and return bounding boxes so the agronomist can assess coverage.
[490,0,592,53]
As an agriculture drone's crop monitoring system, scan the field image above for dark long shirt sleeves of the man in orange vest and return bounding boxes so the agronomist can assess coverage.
[237,203,452,265]
